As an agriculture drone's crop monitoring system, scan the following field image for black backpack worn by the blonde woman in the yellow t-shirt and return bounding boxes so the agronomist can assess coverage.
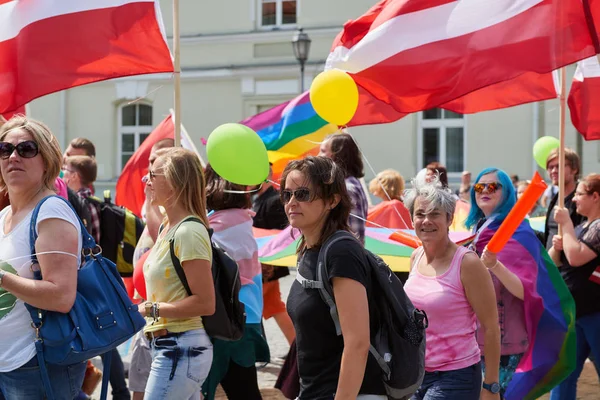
[168,217,246,341]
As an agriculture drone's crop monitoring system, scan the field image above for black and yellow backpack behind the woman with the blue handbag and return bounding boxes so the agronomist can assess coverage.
[85,190,145,277]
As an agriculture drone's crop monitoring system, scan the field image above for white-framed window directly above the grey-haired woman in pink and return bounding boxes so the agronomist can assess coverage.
[418,108,466,174]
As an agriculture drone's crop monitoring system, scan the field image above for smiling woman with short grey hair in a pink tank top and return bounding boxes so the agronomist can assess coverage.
[404,176,500,400]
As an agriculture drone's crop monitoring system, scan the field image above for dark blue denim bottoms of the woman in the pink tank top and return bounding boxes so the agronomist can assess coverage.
[411,363,482,400]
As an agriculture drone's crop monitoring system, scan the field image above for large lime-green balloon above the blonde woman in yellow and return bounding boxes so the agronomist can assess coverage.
[206,124,269,185]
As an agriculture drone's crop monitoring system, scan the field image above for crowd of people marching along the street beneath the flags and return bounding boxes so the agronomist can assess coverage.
[0,116,600,400]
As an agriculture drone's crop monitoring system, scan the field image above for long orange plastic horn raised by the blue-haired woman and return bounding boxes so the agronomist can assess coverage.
[487,172,548,253]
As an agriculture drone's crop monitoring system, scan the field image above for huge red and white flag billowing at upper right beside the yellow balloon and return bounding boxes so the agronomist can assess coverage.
[326,0,597,125]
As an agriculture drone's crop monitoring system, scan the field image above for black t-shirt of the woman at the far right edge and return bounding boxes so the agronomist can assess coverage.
[559,219,600,318]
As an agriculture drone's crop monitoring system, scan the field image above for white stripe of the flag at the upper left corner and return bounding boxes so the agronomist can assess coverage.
[0,0,154,42]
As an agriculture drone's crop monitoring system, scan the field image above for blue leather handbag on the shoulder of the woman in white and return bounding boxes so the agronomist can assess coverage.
[25,196,146,400]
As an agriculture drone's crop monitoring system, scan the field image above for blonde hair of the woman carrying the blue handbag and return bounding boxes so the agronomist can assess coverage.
[0,115,63,191]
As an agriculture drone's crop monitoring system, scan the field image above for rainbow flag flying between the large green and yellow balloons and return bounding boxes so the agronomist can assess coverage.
[241,92,338,179]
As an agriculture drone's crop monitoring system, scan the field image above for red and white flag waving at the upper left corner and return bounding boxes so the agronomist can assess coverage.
[0,0,173,113]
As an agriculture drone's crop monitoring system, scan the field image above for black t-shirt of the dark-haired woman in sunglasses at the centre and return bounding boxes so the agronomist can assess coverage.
[287,241,385,400]
